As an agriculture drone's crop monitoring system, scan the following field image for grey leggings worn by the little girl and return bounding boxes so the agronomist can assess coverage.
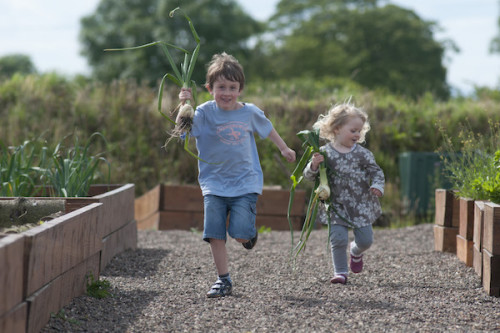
[330,224,373,275]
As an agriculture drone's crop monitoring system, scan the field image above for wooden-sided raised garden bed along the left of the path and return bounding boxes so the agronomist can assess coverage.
[0,184,137,332]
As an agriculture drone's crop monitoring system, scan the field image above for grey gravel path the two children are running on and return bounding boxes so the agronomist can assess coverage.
[43,224,500,332]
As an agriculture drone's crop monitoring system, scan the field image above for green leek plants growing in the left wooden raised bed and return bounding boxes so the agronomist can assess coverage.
[0,133,111,197]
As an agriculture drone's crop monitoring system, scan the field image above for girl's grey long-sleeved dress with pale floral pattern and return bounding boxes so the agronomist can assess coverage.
[304,143,385,228]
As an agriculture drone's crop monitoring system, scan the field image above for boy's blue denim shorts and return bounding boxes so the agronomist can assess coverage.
[203,193,259,242]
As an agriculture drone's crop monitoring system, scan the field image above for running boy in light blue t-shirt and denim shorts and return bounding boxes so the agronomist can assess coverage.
[179,52,295,298]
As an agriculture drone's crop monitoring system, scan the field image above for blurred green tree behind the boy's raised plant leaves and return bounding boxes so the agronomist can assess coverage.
[80,0,262,84]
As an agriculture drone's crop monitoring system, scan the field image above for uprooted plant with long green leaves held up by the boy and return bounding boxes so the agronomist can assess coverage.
[104,7,206,162]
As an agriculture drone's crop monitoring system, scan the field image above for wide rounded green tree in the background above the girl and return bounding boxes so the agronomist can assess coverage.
[254,0,449,98]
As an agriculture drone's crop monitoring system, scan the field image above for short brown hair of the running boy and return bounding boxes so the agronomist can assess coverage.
[205,52,245,91]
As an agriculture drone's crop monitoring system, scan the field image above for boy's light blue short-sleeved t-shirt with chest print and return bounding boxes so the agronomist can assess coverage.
[191,100,273,197]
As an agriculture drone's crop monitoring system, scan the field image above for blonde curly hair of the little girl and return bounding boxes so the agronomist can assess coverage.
[313,102,370,143]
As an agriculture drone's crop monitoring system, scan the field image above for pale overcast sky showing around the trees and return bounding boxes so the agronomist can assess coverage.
[0,0,500,93]
